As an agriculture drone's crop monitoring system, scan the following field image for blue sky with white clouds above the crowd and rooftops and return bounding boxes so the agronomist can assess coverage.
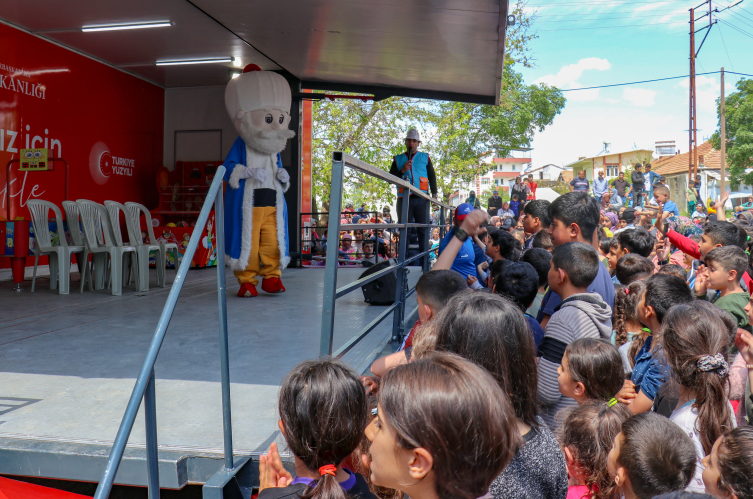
[516,0,753,165]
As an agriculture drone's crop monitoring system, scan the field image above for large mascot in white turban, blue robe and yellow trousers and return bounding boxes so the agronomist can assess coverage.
[224,64,295,297]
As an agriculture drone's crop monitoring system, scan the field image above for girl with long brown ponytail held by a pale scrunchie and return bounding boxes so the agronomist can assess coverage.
[661,301,737,492]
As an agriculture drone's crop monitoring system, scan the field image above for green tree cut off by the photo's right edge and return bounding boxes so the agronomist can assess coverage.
[711,79,753,185]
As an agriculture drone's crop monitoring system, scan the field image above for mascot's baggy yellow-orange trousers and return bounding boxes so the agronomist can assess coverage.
[233,206,282,286]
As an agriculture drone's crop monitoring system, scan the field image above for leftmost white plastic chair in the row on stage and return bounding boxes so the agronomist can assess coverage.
[26,199,84,295]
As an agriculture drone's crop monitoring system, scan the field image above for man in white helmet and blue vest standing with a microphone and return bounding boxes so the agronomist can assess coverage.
[390,128,437,262]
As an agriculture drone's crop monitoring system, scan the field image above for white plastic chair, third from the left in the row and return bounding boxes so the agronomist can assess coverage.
[76,199,136,295]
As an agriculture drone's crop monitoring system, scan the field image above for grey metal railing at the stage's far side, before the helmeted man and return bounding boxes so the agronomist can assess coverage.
[319,152,452,358]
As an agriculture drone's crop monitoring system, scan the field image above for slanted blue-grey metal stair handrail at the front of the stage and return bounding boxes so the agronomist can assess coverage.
[94,166,233,499]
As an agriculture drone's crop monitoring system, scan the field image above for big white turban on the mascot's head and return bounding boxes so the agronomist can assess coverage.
[225,65,291,120]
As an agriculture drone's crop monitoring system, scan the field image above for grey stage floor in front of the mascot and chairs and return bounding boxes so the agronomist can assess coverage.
[0,267,421,488]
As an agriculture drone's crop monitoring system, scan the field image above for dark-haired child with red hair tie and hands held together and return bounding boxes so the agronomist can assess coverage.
[258,359,376,499]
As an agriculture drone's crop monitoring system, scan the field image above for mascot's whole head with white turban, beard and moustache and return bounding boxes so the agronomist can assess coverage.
[225,65,295,154]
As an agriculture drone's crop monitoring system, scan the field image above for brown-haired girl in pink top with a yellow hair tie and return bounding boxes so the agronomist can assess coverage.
[559,399,631,499]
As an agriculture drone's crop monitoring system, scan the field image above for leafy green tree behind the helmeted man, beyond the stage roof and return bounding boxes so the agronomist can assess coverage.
[312,2,565,207]
